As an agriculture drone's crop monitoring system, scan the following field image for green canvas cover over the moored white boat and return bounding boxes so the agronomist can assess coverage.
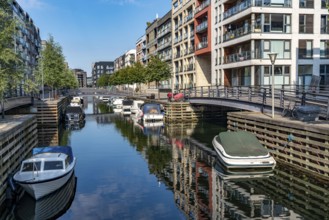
[216,131,268,157]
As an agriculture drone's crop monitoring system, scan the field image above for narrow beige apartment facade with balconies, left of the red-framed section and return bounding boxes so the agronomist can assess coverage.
[172,0,195,89]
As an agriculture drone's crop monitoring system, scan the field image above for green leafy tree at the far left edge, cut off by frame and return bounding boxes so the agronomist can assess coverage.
[0,1,23,118]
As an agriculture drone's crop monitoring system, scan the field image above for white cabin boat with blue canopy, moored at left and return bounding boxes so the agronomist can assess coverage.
[13,146,76,200]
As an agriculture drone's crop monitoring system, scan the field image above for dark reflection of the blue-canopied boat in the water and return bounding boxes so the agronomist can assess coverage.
[15,173,77,220]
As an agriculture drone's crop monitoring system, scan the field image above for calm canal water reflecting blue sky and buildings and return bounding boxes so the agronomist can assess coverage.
[0,98,329,220]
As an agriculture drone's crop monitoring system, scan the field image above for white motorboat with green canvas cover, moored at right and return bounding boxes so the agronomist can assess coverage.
[212,131,276,172]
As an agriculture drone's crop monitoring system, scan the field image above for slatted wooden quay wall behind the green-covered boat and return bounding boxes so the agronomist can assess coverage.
[227,112,329,180]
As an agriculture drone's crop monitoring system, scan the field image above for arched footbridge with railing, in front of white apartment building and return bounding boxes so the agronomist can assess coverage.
[180,86,329,120]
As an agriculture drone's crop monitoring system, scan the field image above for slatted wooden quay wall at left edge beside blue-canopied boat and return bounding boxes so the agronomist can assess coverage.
[0,115,38,205]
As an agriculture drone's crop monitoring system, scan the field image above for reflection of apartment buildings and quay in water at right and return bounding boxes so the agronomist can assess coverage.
[152,125,329,219]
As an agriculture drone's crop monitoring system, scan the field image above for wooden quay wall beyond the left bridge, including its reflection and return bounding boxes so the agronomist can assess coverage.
[35,97,70,146]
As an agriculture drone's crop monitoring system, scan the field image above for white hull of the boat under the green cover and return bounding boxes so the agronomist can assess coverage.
[212,136,276,171]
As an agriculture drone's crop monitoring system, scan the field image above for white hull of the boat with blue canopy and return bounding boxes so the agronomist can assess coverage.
[14,159,76,200]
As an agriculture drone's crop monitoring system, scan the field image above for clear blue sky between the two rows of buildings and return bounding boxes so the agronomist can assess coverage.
[16,0,171,76]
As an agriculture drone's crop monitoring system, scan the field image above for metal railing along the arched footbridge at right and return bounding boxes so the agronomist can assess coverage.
[180,85,329,119]
